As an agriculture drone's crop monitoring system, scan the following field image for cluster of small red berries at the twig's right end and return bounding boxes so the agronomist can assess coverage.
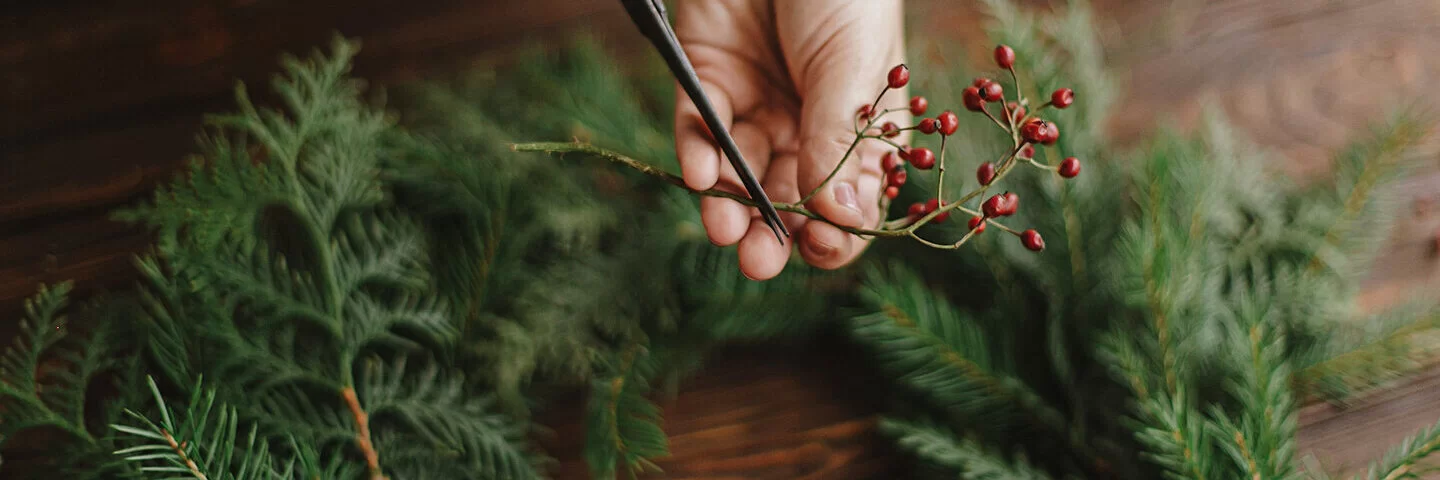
[840,45,1080,251]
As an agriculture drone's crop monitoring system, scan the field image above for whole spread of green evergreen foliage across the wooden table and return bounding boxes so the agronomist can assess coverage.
[0,0,1440,479]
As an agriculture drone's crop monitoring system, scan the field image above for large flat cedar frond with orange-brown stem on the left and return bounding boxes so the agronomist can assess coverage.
[106,35,539,479]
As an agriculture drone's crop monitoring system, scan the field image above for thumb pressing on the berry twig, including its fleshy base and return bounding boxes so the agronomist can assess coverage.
[776,0,906,228]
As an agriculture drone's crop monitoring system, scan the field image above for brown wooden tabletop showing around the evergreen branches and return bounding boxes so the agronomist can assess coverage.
[8,0,1440,479]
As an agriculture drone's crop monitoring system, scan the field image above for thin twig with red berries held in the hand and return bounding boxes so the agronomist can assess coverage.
[511,45,1080,252]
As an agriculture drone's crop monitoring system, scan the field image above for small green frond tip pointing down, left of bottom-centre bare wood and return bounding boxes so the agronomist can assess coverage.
[585,345,670,479]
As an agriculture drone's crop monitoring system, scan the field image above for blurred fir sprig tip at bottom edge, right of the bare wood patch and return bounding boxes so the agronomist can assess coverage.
[880,418,1050,480]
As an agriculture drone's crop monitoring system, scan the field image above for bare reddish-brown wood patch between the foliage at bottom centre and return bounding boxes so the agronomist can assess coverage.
[543,342,907,480]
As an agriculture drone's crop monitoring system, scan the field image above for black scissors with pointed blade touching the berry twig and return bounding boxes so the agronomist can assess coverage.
[621,0,791,244]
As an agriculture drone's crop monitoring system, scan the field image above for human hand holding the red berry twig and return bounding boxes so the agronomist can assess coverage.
[674,0,909,280]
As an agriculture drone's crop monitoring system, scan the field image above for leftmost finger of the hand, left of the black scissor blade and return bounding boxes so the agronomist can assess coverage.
[675,81,739,190]
